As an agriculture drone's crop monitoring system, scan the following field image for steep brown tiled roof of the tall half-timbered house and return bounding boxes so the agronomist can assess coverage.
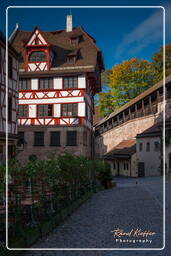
[11,27,104,71]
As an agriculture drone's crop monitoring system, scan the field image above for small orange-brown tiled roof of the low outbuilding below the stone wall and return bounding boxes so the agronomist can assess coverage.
[104,139,136,160]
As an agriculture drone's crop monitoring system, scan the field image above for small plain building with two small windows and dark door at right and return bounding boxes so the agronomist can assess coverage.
[136,120,171,176]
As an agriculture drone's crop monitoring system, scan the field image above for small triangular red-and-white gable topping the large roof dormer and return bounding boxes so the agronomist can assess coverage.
[26,28,48,46]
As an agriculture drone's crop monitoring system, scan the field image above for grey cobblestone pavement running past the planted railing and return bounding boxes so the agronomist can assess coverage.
[24,177,171,256]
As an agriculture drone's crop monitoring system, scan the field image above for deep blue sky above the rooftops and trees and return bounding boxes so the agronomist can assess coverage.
[0,0,171,69]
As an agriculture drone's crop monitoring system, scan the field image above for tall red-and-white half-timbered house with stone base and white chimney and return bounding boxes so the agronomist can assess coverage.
[10,15,104,161]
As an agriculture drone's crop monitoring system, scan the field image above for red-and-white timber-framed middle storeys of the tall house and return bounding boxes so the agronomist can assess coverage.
[19,75,93,129]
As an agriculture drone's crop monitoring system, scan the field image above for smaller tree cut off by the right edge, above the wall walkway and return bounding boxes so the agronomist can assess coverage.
[153,44,171,82]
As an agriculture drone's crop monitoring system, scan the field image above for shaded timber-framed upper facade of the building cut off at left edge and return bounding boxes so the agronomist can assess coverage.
[0,40,18,135]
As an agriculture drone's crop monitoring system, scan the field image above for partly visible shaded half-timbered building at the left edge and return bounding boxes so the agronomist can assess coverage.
[0,32,19,161]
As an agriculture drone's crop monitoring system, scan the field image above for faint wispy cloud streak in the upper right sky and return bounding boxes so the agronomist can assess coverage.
[115,5,171,60]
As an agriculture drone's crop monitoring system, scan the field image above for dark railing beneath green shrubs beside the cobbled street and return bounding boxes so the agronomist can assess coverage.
[0,181,96,244]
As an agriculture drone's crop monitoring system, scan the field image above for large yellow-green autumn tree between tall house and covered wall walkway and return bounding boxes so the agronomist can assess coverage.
[99,58,155,115]
